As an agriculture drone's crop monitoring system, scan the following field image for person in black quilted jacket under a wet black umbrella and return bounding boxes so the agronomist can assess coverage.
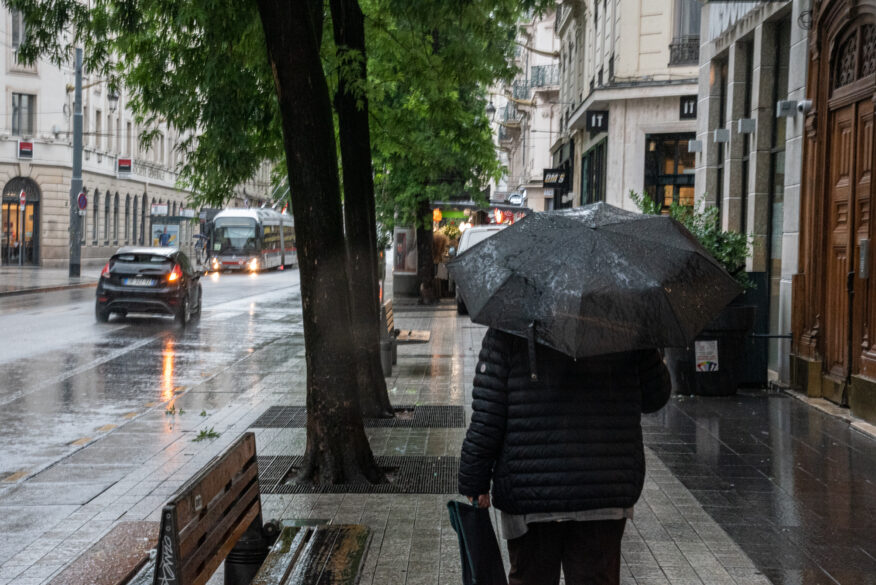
[456,204,739,585]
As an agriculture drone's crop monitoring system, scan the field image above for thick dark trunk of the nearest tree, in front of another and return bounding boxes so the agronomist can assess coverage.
[258,0,383,483]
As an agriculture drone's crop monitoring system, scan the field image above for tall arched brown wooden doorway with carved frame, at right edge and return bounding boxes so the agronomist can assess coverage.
[792,0,876,422]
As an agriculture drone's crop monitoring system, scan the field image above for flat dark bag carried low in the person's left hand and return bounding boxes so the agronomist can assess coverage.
[447,500,508,585]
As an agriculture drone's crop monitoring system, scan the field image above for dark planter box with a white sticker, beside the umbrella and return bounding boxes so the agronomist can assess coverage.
[666,305,756,396]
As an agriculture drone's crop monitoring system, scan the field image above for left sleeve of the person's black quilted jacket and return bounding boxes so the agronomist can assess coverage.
[459,329,510,497]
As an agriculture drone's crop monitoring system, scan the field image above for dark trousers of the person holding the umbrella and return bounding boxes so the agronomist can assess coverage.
[508,519,627,585]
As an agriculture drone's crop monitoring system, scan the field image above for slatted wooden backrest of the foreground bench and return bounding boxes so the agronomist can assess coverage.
[153,433,261,585]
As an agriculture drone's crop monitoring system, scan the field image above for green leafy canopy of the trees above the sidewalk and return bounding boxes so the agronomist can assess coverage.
[4,0,526,214]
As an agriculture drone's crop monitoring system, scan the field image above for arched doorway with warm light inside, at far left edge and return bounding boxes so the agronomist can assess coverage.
[0,177,40,265]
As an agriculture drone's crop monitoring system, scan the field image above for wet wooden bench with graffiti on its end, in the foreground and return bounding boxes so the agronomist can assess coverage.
[53,433,370,585]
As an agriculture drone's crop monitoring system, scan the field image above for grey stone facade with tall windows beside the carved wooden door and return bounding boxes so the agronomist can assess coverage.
[696,0,809,383]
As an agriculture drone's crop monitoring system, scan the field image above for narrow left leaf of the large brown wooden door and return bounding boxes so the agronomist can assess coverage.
[824,104,856,378]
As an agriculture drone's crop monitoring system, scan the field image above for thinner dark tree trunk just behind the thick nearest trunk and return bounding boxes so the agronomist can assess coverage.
[330,0,395,418]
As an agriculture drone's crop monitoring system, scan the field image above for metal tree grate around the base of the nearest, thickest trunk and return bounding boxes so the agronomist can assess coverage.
[258,456,459,494]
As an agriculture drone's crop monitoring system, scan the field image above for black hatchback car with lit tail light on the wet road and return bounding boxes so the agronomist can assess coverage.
[94,246,201,326]
